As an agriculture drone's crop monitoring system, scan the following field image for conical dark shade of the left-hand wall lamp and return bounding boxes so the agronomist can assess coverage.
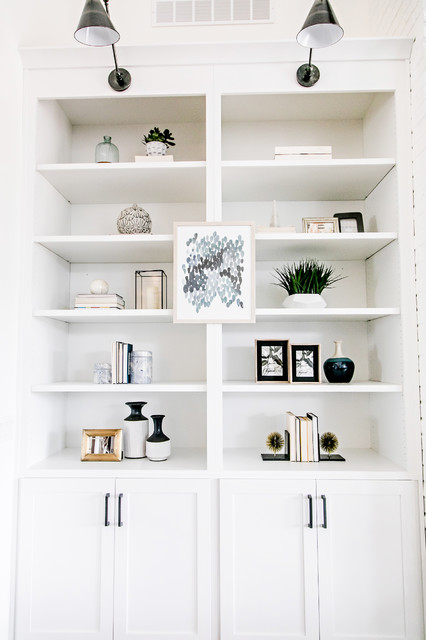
[74,0,120,47]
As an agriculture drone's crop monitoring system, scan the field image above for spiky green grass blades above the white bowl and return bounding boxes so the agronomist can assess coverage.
[273,258,345,296]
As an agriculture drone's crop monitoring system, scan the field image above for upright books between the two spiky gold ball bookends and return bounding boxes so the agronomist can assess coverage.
[286,411,320,462]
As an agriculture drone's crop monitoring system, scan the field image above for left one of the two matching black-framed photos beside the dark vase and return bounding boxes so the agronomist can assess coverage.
[255,340,290,382]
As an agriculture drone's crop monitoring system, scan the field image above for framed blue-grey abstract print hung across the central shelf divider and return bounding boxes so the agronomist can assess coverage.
[173,222,255,323]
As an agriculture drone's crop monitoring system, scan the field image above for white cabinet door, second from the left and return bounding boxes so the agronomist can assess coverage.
[114,479,211,640]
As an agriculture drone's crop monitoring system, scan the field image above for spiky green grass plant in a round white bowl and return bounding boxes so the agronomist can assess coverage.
[273,258,344,309]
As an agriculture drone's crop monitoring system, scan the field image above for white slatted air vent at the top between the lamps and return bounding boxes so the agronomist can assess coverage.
[152,0,272,27]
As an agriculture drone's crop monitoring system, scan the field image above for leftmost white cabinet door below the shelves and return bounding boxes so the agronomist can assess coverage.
[15,479,114,640]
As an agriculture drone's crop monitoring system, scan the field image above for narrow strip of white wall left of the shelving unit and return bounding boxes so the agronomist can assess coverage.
[0,9,22,640]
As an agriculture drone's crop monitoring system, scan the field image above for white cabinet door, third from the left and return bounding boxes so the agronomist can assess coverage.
[221,479,318,640]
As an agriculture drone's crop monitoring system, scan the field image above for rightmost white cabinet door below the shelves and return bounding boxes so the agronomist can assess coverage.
[318,480,423,640]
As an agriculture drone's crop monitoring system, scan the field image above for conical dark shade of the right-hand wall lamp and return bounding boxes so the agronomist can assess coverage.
[296,0,343,49]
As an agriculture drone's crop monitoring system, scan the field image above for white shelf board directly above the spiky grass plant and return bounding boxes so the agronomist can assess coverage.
[256,230,397,261]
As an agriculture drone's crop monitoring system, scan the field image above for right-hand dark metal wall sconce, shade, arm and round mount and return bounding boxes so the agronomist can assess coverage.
[296,0,343,87]
